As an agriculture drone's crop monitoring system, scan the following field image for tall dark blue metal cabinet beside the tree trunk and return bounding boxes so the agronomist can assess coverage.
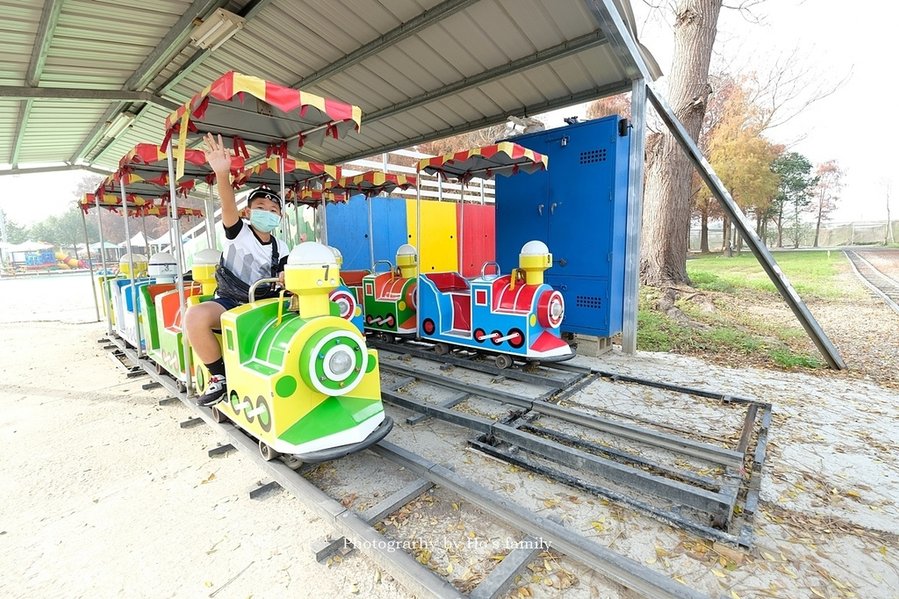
[496,116,630,337]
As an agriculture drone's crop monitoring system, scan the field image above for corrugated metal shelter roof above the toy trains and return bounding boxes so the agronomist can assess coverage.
[0,0,658,172]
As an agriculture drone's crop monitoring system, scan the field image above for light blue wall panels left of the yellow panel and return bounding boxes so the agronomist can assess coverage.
[327,194,407,270]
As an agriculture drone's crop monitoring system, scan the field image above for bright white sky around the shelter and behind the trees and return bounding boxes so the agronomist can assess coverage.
[0,0,899,230]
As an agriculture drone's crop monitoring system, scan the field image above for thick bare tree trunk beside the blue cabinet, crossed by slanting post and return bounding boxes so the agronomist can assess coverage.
[640,0,722,285]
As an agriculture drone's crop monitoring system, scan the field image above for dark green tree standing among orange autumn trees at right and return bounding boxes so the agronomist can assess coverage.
[772,152,818,248]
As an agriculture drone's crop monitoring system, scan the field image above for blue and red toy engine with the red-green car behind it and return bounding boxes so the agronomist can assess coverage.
[362,241,574,368]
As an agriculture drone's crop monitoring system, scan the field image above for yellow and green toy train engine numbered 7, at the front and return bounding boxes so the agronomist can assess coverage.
[198,242,393,462]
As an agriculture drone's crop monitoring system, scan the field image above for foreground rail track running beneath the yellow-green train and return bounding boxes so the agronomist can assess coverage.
[104,338,707,599]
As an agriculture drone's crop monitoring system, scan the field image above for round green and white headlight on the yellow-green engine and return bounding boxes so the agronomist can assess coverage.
[300,327,368,396]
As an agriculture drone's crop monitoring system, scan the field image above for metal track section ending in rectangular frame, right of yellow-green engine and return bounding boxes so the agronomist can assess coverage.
[372,340,771,547]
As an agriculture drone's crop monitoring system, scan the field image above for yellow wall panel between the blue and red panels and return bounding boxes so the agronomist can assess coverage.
[406,200,459,272]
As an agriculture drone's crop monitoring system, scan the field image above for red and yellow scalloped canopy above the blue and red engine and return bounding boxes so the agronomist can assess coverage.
[417,141,549,183]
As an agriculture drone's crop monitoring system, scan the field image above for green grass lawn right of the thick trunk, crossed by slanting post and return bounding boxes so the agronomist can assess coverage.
[637,251,857,368]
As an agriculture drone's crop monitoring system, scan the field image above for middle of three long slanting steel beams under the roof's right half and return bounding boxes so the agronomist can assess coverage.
[365,30,608,126]
